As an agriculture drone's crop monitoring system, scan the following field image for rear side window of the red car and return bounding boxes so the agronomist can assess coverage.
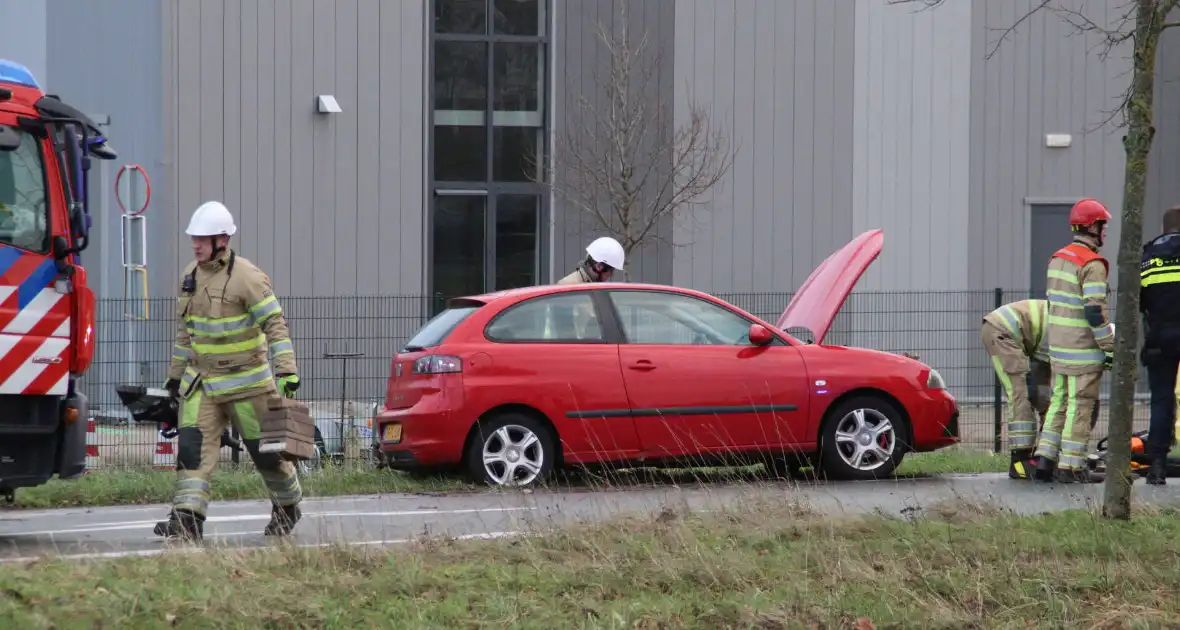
[484,293,605,343]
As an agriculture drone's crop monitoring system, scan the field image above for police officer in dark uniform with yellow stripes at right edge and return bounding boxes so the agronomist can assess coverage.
[1139,205,1180,486]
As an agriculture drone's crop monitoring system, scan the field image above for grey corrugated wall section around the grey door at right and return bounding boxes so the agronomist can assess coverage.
[968,0,1129,289]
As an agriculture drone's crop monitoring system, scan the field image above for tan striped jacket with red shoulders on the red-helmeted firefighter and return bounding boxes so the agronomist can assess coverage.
[1045,236,1114,376]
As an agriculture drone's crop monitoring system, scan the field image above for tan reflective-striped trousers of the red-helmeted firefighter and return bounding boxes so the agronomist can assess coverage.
[1036,372,1102,471]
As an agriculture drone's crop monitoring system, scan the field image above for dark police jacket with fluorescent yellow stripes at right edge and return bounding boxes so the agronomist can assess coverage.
[1139,232,1180,357]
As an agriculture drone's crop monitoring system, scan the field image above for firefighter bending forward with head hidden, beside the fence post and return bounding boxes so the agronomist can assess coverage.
[979,300,1049,479]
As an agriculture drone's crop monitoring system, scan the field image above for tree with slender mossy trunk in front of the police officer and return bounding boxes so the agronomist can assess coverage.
[889,0,1180,519]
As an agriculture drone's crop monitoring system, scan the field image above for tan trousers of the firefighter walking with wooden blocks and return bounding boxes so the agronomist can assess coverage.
[172,389,303,517]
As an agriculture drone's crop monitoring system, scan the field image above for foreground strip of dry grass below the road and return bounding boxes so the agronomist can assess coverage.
[0,503,1180,630]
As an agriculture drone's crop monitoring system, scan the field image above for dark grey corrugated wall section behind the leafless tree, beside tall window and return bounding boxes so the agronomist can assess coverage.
[551,0,684,282]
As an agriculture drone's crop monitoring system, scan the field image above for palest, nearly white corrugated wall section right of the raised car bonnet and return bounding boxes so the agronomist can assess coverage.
[852,0,971,291]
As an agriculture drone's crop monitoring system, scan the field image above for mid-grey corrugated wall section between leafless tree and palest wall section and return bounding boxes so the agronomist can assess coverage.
[674,0,856,293]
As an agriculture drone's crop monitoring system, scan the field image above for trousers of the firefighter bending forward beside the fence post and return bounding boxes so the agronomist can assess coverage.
[979,321,1049,451]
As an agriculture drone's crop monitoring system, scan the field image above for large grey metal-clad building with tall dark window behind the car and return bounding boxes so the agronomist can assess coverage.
[0,0,1180,412]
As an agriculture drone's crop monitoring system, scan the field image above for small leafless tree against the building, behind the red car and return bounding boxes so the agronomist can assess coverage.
[533,0,733,277]
